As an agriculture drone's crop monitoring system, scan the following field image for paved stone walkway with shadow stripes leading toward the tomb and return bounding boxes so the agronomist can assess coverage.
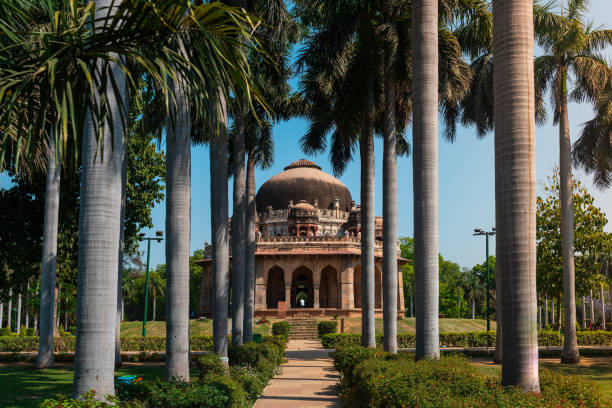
[254,340,342,408]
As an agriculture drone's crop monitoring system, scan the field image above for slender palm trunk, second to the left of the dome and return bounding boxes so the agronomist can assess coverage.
[232,106,246,345]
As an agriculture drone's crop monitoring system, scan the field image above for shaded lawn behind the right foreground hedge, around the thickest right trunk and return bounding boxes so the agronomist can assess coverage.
[473,357,612,400]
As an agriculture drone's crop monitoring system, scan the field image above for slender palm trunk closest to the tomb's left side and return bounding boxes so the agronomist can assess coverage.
[243,147,257,343]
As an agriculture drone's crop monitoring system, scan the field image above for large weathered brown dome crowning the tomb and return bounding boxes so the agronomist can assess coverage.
[255,159,351,211]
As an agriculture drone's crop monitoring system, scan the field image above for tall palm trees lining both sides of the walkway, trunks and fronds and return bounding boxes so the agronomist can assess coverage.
[0,0,609,396]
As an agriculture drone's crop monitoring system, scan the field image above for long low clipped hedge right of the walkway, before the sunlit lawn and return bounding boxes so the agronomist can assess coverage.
[321,331,612,349]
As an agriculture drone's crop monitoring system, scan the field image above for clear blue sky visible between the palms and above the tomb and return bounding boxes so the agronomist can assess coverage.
[0,0,612,274]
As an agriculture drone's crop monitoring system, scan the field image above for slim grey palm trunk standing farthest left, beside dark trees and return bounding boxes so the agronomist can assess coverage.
[36,136,61,368]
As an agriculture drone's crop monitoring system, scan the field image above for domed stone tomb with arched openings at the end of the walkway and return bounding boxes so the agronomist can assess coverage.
[199,159,407,316]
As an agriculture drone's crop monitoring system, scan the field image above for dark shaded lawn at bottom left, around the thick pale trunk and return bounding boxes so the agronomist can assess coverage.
[0,364,172,408]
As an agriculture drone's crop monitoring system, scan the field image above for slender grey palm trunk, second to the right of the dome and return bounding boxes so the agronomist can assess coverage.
[383,67,397,353]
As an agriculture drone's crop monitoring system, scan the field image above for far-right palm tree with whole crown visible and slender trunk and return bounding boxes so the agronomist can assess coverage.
[535,0,612,364]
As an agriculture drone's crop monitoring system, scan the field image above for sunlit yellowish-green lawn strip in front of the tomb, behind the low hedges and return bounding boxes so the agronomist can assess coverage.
[121,317,495,336]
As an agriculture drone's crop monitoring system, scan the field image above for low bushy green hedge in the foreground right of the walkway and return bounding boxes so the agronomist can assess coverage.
[334,346,608,408]
